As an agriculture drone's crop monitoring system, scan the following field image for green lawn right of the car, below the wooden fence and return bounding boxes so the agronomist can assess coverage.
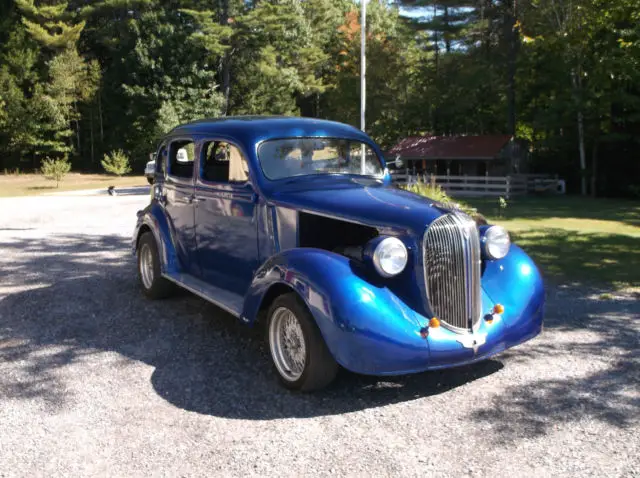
[465,196,640,290]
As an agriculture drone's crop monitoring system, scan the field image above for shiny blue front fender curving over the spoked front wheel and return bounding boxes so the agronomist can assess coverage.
[243,248,429,374]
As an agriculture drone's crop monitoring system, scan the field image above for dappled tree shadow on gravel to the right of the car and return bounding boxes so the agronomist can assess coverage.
[472,289,640,443]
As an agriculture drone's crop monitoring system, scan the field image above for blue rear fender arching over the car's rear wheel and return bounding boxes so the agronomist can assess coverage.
[132,202,179,273]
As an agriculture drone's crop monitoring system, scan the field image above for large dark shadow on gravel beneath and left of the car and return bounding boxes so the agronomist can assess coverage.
[0,235,502,420]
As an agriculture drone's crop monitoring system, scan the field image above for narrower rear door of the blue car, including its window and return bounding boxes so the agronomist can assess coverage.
[162,138,199,275]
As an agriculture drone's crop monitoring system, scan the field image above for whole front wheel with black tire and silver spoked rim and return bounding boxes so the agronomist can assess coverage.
[267,293,338,392]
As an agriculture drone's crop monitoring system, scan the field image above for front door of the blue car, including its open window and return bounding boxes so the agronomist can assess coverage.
[195,140,259,296]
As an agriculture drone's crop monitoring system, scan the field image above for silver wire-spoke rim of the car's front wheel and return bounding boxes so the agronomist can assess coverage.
[269,307,307,382]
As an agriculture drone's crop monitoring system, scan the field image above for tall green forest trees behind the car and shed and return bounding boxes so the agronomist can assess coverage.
[0,0,640,197]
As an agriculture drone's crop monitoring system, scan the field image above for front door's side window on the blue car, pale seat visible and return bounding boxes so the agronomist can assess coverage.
[200,141,249,183]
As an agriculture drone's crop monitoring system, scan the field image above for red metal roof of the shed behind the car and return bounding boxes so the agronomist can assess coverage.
[387,134,511,159]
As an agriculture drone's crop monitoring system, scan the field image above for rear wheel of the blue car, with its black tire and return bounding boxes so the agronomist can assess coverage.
[137,231,175,299]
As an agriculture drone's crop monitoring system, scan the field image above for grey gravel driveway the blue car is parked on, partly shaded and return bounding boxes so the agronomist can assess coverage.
[0,190,640,477]
